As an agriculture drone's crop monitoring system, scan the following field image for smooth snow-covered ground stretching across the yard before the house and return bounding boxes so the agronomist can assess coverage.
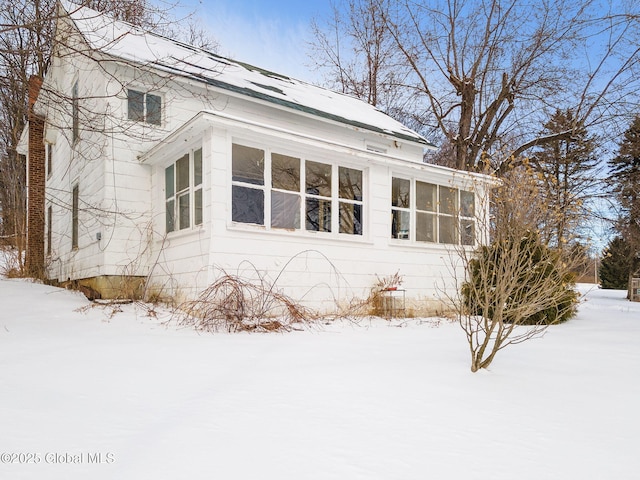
[0,264,640,480]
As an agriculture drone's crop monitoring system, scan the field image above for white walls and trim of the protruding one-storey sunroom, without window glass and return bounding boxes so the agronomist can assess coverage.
[144,91,490,312]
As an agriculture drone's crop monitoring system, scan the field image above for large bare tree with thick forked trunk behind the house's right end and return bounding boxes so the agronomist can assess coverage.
[316,0,640,172]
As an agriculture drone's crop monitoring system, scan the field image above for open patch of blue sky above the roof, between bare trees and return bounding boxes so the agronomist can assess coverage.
[180,0,331,81]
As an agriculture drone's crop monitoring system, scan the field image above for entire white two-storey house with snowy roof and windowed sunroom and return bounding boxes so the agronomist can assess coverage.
[24,1,489,311]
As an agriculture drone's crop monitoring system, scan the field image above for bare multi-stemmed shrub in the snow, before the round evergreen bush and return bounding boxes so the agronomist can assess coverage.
[453,169,577,372]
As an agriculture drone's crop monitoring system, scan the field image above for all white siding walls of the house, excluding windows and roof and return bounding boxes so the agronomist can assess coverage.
[37,13,492,309]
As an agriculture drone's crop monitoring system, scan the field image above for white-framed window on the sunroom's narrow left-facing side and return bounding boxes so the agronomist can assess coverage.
[162,146,204,235]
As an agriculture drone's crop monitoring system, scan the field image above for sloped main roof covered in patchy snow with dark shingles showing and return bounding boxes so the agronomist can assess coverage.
[61,0,431,146]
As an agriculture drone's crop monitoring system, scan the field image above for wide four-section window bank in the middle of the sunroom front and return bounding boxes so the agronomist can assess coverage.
[231,144,364,235]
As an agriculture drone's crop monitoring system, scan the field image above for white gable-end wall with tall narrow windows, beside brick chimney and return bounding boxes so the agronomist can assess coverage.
[41,41,106,281]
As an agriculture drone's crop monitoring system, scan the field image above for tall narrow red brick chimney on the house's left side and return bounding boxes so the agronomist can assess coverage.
[25,76,46,277]
